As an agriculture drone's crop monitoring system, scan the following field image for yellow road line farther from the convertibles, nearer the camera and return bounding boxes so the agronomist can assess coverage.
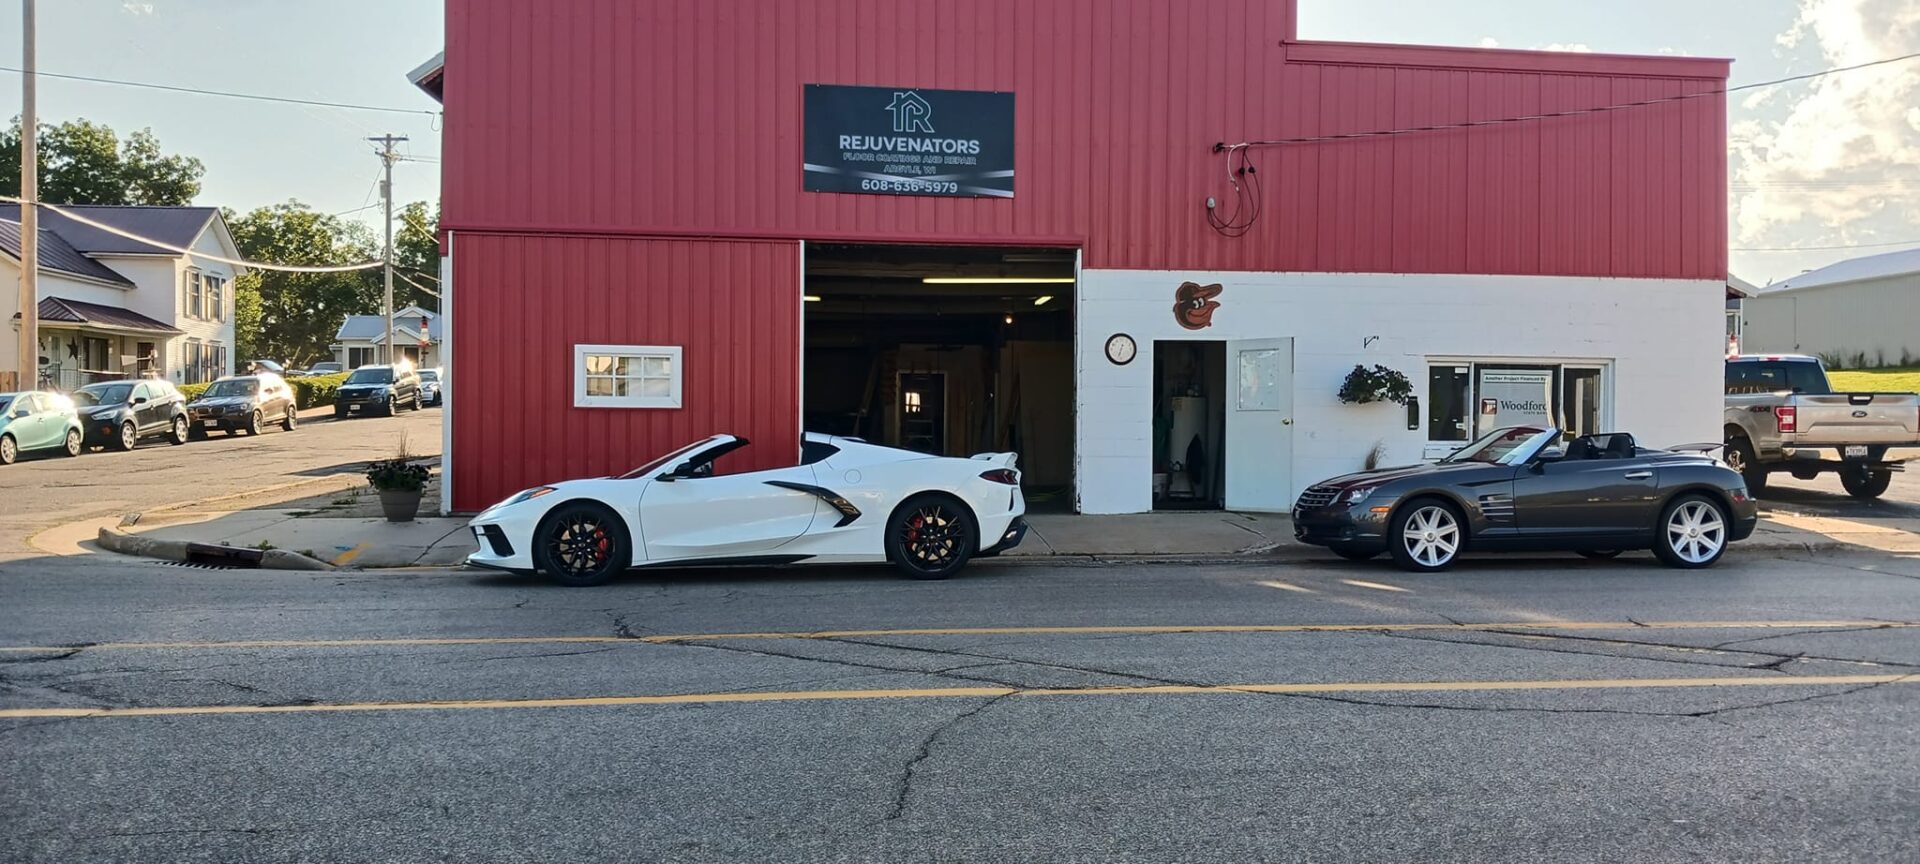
[0,674,1920,718]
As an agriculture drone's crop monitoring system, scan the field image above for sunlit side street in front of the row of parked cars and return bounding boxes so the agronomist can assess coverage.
[0,407,442,561]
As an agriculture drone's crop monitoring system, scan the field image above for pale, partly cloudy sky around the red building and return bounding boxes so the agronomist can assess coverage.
[0,0,1920,284]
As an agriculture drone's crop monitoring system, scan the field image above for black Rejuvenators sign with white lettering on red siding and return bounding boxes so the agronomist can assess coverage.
[804,84,1014,198]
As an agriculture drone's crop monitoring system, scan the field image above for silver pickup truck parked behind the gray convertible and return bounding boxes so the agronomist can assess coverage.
[1726,353,1920,497]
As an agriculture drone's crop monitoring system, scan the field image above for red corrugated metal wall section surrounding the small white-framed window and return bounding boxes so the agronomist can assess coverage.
[449,234,801,511]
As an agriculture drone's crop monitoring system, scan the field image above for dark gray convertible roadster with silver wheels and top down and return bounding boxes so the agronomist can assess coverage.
[1294,426,1759,570]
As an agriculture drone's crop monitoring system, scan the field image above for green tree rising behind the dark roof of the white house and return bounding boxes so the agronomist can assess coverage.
[0,117,205,204]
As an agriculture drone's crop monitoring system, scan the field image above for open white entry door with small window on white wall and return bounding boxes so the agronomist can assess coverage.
[1227,338,1294,513]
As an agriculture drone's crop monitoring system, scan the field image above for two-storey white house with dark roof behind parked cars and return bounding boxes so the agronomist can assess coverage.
[0,205,246,390]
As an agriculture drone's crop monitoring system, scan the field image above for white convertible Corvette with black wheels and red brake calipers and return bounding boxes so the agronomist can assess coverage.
[467,434,1027,586]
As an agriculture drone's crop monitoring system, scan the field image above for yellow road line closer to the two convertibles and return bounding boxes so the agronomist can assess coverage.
[0,620,1920,655]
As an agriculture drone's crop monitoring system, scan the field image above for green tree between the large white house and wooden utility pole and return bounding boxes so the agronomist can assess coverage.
[227,202,382,367]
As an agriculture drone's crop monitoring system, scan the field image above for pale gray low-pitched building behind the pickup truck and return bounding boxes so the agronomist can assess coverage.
[1741,250,1920,367]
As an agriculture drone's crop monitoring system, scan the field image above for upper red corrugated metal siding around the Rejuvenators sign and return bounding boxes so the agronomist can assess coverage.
[444,0,1726,278]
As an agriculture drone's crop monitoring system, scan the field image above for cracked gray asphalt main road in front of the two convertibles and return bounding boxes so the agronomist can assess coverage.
[0,549,1920,862]
